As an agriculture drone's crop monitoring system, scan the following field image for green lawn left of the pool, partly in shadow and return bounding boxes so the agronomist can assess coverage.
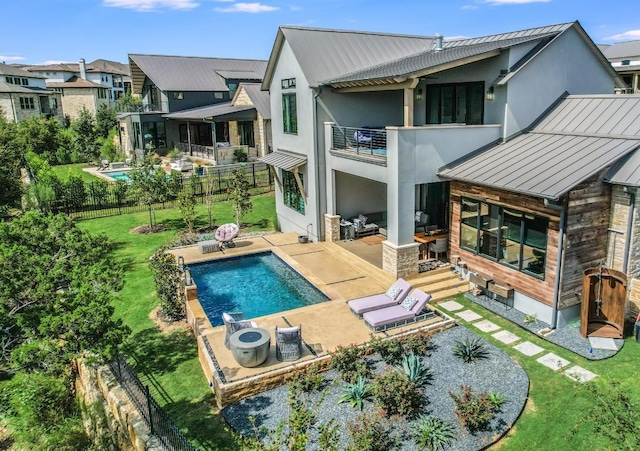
[78,194,276,451]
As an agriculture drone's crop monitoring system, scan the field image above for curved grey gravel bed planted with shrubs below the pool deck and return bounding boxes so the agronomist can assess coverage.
[222,326,529,451]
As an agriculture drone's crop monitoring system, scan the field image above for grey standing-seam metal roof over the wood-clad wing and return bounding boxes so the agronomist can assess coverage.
[438,95,640,200]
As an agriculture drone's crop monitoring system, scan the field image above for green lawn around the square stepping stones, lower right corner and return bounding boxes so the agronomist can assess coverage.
[440,295,640,451]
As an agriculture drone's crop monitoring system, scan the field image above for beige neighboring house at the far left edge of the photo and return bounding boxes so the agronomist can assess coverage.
[0,64,63,122]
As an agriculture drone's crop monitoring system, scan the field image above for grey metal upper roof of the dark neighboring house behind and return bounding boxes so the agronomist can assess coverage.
[129,54,267,94]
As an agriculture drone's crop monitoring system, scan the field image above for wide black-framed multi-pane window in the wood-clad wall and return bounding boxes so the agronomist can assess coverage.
[460,198,549,278]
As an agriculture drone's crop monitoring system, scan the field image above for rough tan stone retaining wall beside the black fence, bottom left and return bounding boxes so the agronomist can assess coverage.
[76,361,165,451]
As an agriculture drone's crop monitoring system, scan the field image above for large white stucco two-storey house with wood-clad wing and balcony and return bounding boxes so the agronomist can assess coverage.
[263,22,640,325]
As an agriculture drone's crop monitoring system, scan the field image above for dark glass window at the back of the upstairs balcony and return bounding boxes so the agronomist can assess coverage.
[427,82,484,125]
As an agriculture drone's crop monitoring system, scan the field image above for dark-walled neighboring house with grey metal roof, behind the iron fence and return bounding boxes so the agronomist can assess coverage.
[118,54,267,160]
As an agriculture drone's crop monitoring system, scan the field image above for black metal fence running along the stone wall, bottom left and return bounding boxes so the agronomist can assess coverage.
[109,355,198,451]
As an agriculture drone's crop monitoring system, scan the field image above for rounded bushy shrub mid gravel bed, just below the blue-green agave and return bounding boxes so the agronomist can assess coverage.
[372,369,423,416]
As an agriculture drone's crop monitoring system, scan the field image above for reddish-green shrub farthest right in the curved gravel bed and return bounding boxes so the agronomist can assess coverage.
[449,385,504,432]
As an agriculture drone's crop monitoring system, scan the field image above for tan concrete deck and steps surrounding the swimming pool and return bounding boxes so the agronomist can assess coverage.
[172,233,460,407]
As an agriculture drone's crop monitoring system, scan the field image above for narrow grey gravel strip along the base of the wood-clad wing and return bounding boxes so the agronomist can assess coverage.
[466,293,624,360]
